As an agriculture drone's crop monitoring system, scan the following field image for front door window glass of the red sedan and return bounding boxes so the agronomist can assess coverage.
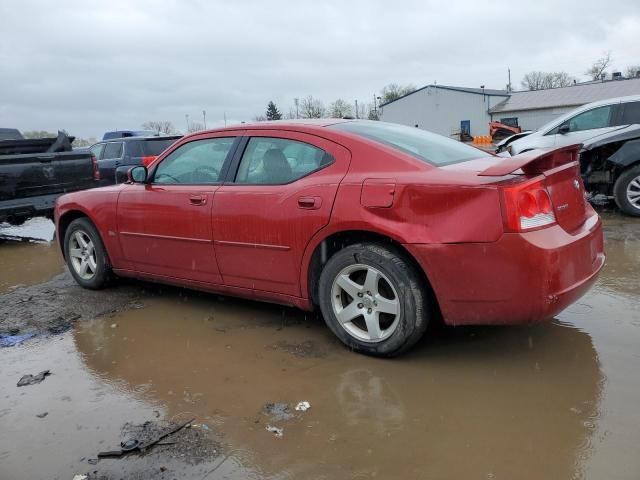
[153,137,235,185]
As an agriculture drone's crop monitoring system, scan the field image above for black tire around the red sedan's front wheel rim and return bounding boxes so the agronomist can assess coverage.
[63,218,111,290]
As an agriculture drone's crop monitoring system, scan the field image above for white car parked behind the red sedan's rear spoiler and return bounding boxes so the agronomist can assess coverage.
[506,95,640,155]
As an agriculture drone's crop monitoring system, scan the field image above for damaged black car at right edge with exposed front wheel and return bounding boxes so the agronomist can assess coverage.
[580,125,640,217]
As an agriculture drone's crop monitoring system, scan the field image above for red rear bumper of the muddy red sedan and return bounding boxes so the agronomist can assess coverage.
[405,213,605,325]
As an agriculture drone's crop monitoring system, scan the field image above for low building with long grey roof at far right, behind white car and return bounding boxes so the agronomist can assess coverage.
[490,78,640,130]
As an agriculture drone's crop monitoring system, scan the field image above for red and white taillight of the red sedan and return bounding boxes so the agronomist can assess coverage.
[502,179,556,232]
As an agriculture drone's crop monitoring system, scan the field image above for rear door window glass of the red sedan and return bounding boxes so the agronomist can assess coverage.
[235,137,333,185]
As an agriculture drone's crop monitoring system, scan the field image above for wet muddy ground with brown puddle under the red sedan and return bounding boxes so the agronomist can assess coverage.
[0,212,640,480]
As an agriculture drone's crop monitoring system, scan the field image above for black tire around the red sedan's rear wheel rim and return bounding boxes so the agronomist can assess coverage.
[318,243,431,357]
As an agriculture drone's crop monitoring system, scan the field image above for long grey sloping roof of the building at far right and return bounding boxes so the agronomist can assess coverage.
[489,78,640,113]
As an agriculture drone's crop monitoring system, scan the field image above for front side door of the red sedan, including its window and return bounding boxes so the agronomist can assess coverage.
[117,136,237,284]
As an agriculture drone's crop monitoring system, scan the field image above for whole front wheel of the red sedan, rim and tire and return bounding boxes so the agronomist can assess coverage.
[64,218,111,290]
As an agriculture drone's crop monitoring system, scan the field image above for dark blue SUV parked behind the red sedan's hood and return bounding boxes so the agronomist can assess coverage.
[90,135,181,186]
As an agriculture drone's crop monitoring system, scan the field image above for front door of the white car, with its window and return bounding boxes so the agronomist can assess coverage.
[552,104,618,147]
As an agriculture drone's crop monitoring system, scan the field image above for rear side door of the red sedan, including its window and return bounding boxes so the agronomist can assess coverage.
[213,130,350,296]
